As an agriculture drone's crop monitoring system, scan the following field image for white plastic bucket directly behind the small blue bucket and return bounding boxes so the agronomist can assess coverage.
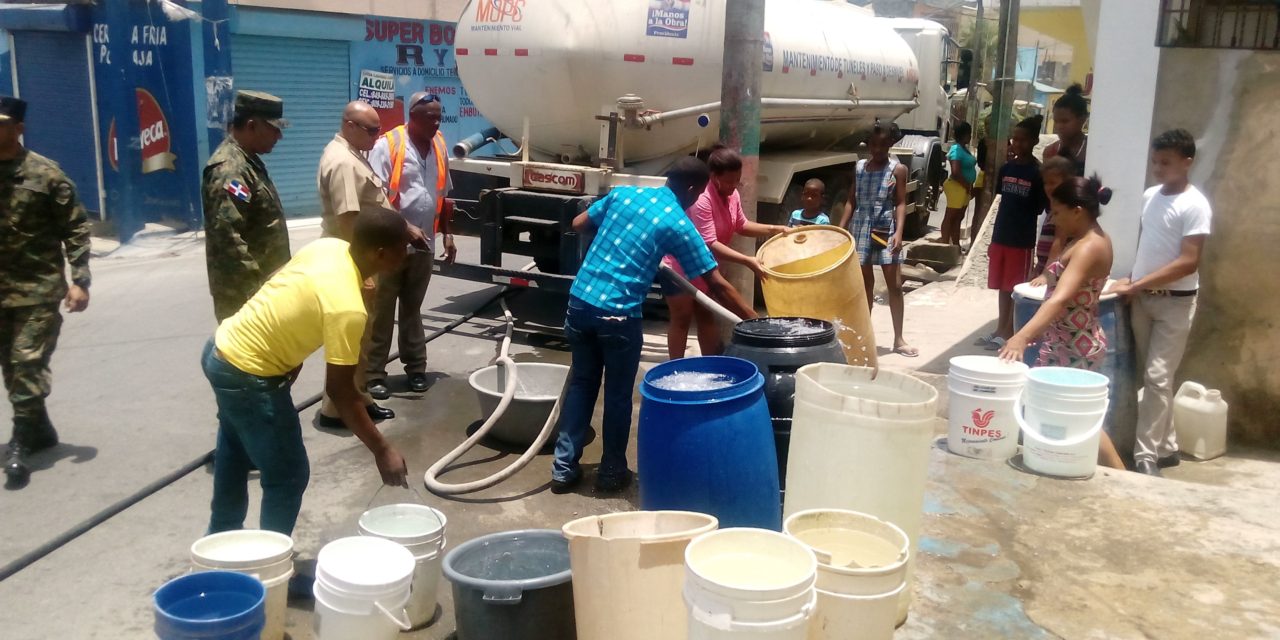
[191,529,293,640]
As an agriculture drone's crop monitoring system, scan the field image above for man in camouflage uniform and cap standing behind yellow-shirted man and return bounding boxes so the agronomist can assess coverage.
[201,91,289,323]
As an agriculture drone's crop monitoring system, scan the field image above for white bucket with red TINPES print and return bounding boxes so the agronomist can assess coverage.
[947,356,1027,460]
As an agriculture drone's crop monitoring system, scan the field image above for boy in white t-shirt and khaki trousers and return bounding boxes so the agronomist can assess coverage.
[1112,129,1213,476]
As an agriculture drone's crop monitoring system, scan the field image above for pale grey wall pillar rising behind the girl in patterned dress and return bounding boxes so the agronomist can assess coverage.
[1088,0,1167,276]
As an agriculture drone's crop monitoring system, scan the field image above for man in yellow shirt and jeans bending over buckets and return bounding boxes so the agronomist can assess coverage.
[202,210,410,535]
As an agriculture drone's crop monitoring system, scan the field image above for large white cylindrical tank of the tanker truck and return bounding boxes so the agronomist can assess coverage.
[454,0,920,163]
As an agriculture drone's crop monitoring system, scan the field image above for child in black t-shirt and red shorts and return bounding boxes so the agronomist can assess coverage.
[983,115,1048,351]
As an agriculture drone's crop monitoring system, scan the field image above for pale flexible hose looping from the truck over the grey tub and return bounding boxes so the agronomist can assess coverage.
[424,262,572,495]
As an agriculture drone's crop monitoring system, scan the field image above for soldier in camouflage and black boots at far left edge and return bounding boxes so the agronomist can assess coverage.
[0,96,90,486]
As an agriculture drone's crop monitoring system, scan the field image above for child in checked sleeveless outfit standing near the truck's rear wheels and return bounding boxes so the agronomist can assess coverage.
[840,123,920,358]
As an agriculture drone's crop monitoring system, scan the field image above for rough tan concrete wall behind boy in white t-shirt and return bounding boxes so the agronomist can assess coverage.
[1152,47,1280,447]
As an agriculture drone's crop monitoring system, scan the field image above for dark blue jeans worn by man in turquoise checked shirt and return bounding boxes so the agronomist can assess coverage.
[552,298,644,481]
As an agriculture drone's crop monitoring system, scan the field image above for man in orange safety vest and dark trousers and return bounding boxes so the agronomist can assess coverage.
[367,92,457,399]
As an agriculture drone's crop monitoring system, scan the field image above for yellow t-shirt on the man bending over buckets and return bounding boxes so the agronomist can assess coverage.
[214,238,369,378]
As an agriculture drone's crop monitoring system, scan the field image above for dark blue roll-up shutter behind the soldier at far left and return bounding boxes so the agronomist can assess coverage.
[13,31,101,212]
